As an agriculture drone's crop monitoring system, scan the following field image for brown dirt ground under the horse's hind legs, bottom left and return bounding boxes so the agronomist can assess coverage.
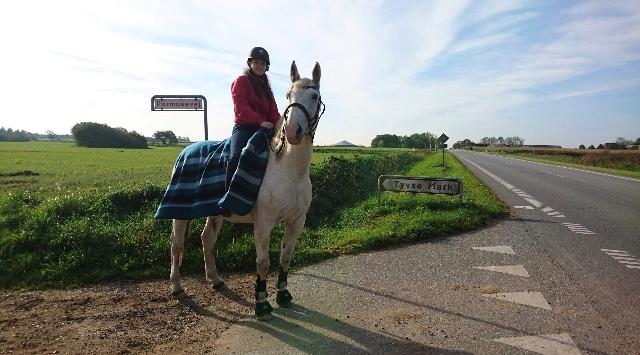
[0,274,264,354]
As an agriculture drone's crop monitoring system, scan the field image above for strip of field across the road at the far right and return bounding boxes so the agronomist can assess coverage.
[474,147,640,178]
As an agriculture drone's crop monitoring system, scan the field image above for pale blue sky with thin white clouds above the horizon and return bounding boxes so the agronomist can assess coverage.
[0,0,640,147]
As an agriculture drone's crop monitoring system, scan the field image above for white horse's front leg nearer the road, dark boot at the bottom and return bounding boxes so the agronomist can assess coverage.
[276,214,306,307]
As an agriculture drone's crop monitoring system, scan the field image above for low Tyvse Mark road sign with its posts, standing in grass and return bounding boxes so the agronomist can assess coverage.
[378,175,462,204]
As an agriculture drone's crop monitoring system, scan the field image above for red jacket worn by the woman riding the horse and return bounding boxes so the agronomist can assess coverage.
[231,75,280,126]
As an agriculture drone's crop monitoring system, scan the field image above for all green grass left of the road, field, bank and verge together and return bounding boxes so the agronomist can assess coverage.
[0,142,505,288]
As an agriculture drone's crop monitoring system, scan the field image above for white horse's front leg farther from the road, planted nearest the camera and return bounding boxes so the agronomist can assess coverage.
[253,221,273,320]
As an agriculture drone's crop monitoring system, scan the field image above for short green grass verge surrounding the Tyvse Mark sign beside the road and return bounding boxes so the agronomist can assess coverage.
[294,153,506,263]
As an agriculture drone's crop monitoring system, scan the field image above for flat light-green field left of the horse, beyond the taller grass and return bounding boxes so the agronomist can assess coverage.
[0,142,182,196]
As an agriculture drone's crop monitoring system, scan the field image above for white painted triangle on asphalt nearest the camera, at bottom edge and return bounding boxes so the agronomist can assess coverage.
[493,333,582,355]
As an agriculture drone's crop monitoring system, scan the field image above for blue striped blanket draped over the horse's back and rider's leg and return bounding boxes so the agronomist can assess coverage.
[155,128,269,219]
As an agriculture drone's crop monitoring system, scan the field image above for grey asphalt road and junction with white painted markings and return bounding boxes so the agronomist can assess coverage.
[210,152,640,354]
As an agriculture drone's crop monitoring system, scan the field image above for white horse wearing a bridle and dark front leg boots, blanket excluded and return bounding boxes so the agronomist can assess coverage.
[170,61,322,320]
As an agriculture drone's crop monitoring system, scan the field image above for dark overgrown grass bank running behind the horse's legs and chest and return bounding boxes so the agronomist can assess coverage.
[0,152,422,288]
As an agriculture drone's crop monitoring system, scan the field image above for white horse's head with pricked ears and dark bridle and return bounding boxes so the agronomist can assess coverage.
[284,60,324,145]
